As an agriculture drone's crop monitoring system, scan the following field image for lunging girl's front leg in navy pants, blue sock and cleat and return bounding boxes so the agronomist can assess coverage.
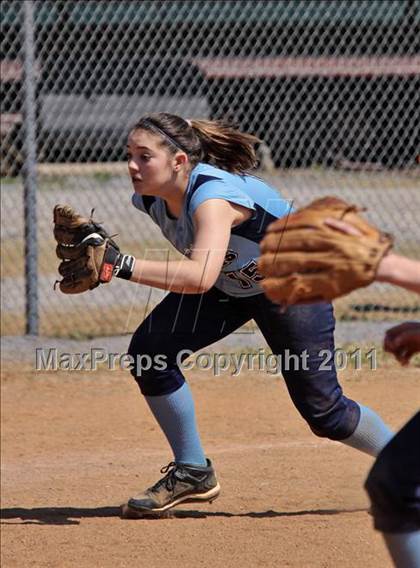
[124,289,250,515]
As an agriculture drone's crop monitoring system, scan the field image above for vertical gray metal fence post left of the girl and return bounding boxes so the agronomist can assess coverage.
[23,0,39,335]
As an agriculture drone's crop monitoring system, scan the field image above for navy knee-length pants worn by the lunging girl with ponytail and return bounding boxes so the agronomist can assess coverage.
[128,288,360,440]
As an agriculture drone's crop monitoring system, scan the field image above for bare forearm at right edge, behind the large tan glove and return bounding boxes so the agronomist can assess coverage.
[376,254,420,294]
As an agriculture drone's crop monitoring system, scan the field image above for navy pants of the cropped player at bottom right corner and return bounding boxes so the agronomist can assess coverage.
[365,412,420,533]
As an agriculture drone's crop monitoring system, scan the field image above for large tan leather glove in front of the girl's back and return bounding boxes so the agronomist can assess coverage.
[258,197,392,305]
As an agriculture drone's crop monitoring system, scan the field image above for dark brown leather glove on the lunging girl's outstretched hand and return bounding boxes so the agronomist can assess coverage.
[54,205,135,294]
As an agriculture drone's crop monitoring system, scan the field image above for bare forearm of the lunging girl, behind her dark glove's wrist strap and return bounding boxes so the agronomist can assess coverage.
[130,258,212,294]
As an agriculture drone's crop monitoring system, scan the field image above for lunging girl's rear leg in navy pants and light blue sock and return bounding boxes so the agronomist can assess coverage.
[254,296,393,456]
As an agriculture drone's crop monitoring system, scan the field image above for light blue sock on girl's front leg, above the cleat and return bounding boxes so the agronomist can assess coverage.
[145,383,207,465]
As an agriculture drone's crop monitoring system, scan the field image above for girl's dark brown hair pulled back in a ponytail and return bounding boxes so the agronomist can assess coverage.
[133,112,260,174]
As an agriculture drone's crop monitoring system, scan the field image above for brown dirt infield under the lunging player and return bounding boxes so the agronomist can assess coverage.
[1,363,420,568]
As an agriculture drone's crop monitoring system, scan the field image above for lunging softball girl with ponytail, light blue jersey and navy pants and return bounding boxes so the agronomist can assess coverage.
[117,113,392,515]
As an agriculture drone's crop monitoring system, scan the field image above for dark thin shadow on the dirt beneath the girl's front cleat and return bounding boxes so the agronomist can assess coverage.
[0,507,367,525]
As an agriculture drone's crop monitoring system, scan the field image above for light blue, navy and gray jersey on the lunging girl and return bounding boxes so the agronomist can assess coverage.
[132,163,291,296]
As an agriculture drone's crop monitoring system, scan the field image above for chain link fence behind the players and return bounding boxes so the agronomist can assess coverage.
[1,0,420,337]
